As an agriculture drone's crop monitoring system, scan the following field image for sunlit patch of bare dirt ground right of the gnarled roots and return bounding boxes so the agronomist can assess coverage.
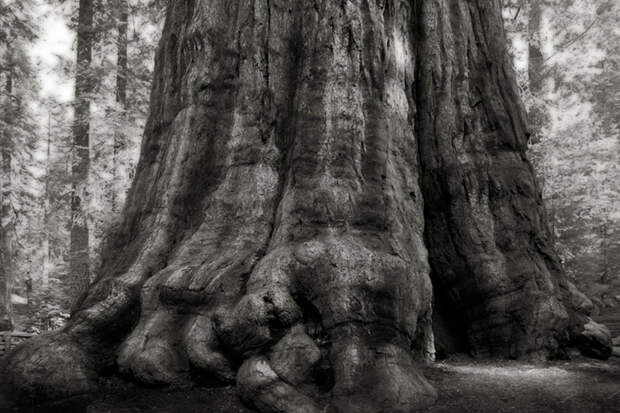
[425,358,620,413]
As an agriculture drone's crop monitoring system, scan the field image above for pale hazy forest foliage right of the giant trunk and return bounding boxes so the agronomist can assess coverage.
[504,0,620,307]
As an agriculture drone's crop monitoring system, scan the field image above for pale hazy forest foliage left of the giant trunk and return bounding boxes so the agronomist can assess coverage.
[0,0,164,330]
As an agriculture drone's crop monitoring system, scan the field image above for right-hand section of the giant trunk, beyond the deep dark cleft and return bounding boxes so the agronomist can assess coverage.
[417,1,569,357]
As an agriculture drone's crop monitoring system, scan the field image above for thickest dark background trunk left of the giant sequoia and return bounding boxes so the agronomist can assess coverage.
[69,0,93,298]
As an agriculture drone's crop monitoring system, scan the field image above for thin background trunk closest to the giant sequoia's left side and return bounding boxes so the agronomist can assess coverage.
[112,0,129,212]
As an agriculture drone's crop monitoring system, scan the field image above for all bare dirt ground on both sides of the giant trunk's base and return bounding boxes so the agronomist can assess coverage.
[0,358,620,413]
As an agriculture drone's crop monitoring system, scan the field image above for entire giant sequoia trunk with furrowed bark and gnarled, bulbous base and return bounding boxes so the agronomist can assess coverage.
[5,0,572,412]
